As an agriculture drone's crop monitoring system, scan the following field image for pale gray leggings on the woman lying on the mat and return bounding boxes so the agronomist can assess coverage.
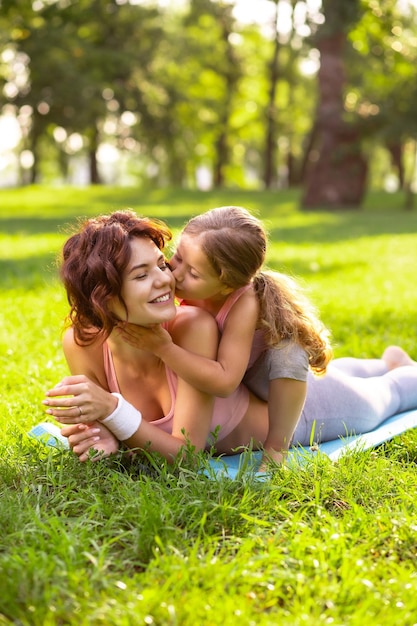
[244,351,417,445]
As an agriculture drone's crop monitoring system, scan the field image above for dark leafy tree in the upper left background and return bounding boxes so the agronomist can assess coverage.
[1,0,160,183]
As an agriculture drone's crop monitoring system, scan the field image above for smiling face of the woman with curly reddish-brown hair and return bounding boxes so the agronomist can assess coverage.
[109,237,175,326]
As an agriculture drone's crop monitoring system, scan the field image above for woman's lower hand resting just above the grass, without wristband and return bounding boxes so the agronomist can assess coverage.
[61,422,119,462]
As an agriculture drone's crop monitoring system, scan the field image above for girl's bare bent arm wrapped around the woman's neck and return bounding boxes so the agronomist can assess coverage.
[120,291,259,397]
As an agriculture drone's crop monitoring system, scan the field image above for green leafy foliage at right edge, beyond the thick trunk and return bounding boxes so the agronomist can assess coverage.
[346,0,417,204]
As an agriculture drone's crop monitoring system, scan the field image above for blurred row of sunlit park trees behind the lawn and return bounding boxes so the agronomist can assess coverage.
[0,0,417,209]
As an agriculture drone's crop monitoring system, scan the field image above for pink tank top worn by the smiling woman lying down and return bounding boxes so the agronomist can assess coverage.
[103,342,249,445]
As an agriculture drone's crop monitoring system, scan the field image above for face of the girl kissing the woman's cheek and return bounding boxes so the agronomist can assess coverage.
[170,233,231,300]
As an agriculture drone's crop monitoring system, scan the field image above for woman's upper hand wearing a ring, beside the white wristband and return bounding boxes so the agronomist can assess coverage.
[42,375,118,424]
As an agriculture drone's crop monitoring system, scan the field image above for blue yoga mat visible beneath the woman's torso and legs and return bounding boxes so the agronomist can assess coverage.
[210,409,417,480]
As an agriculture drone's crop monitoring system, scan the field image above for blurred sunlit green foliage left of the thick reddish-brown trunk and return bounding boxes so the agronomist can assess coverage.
[0,0,324,187]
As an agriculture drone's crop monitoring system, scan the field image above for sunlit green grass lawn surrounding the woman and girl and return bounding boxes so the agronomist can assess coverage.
[0,187,417,626]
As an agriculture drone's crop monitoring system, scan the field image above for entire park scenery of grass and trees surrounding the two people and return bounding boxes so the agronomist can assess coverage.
[4,0,417,626]
